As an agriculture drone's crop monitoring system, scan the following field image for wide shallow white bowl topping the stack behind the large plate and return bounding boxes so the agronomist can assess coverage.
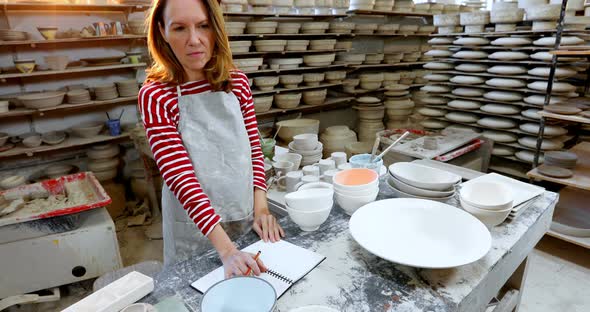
[389,162,461,191]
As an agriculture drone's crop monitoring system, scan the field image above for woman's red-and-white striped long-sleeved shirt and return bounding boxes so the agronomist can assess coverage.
[139,71,266,235]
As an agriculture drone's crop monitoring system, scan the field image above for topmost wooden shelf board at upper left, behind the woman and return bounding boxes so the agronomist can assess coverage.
[0,2,150,12]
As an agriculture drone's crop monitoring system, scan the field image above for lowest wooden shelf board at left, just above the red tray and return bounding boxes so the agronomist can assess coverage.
[0,133,130,158]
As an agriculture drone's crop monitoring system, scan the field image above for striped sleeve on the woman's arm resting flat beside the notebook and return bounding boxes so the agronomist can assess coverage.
[232,71,267,192]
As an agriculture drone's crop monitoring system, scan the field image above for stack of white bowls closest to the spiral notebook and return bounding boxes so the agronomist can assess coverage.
[285,188,334,231]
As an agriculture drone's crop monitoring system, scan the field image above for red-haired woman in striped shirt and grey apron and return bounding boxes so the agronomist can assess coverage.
[139,0,284,277]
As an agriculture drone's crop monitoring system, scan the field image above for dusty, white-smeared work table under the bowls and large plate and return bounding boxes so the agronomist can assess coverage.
[141,183,558,312]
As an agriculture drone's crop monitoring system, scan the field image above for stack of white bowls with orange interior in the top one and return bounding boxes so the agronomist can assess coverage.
[333,168,379,215]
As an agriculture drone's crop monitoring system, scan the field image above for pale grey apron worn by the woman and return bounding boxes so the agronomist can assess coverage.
[162,87,254,265]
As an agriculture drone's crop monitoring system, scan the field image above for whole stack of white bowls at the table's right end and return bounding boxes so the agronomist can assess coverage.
[459,181,514,227]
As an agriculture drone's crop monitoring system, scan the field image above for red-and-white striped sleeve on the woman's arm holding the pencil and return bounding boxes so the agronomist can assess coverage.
[138,83,221,236]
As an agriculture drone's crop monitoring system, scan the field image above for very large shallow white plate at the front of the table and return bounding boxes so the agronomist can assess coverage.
[349,198,492,269]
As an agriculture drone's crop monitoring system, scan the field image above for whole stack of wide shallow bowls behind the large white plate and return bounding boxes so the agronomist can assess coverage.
[387,162,461,201]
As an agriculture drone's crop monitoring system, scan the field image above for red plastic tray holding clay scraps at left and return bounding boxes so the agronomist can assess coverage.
[0,172,112,226]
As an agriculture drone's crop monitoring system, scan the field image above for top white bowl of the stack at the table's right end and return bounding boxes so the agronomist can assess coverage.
[460,181,513,211]
